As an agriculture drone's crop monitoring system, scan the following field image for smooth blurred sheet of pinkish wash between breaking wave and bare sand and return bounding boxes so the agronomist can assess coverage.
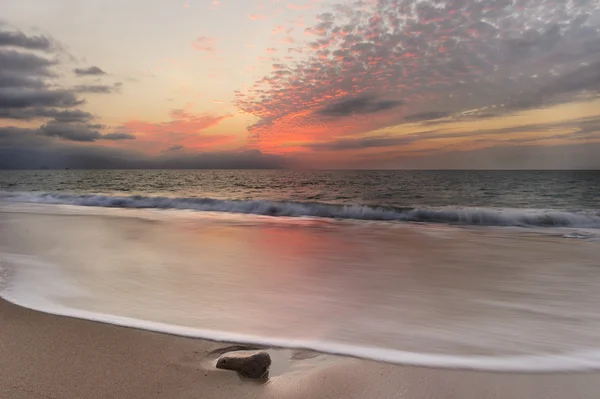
[0,205,600,372]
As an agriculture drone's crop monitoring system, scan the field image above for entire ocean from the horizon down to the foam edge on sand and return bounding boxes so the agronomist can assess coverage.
[0,170,600,372]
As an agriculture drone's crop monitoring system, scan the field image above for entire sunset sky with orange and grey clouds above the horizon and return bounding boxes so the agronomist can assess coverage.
[0,0,600,169]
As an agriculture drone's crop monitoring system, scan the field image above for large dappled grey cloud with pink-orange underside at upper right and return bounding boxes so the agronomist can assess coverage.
[235,0,600,148]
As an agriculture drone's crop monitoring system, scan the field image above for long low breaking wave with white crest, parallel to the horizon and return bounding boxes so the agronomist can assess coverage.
[0,192,600,229]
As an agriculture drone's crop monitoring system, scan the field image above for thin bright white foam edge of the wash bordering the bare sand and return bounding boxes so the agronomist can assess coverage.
[0,254,600,372]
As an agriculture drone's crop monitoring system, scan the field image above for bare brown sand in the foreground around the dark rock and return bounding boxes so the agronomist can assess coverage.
[0,300,600,399]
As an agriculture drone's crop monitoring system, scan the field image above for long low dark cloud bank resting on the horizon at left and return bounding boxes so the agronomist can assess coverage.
[0,127,288,169]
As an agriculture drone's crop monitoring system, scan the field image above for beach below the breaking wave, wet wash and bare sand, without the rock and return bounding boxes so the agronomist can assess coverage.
[0,184,600,399]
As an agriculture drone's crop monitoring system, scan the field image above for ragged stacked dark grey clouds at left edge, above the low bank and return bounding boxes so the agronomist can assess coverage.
[0,27,125,155]
